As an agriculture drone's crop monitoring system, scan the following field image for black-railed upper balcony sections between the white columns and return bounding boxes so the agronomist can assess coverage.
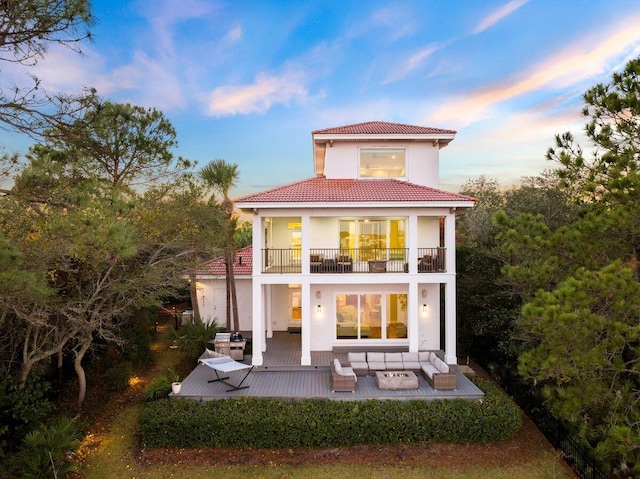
[262,248,446,274]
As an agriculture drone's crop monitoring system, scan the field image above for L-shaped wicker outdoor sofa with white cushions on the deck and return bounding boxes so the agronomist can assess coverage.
[347,351,456,390]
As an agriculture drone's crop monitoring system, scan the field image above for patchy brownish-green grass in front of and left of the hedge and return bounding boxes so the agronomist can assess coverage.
[79,330,575,479]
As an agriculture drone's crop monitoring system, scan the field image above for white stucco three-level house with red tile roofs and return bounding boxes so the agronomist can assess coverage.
[192,121,474,365]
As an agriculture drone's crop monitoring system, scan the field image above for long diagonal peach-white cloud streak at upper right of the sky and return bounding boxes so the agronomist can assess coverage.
[432,17,640,127]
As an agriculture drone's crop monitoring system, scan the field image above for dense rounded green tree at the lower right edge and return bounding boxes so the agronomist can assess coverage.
[519,263,640,474]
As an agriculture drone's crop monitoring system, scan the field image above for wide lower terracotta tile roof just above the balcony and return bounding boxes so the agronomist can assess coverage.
[235,176,475,206]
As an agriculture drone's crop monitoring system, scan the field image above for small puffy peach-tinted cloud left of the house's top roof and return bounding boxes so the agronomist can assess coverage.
[202,73,307,117]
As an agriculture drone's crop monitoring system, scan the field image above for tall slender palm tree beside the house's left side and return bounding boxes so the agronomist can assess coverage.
[200,160,240,331]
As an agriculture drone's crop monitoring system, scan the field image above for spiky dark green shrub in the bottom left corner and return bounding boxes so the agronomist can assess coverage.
[11,416,81,479]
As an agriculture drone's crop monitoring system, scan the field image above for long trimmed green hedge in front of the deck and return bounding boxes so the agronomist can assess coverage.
[140,380,522,448]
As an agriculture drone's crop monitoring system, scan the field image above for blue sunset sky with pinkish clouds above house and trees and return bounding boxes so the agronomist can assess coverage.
[0,0,640,197]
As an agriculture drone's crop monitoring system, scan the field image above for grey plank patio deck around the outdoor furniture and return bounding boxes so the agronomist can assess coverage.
[171,332,484,401]
